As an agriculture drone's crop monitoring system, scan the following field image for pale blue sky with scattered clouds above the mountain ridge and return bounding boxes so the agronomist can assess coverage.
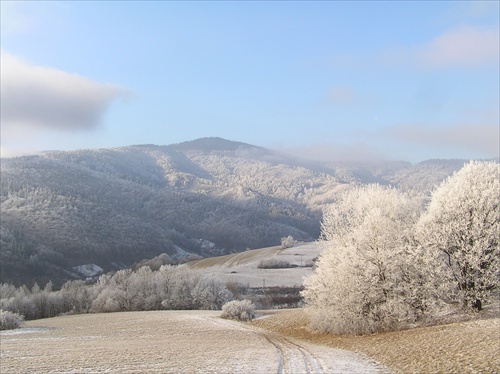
[0,0,500,162]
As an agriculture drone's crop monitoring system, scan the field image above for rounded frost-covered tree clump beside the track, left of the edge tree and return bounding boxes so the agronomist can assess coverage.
[303,185,427,334]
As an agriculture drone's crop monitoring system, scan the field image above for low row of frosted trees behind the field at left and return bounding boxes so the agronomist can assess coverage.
[0,265,234,320]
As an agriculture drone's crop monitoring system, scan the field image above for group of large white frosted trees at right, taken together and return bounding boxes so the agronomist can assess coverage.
[303,162,500,334]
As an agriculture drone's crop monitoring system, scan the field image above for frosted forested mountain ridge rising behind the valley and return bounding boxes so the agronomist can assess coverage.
[0,138,464,285]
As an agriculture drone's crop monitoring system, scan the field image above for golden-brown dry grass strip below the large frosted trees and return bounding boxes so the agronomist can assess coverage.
[253,309,500,373]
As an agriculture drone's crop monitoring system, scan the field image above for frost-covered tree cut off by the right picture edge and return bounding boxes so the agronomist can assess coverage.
[418,161,500,310]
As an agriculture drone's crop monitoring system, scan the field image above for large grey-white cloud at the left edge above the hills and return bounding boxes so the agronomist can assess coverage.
[1,51,128,131]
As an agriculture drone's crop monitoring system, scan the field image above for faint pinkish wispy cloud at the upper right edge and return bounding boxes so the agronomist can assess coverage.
[381,26,500,69]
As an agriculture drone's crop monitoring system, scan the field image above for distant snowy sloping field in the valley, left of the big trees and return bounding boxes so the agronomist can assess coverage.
[187,242,320,287]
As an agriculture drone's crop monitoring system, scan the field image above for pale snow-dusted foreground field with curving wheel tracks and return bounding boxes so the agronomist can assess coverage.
[0,311,384,374]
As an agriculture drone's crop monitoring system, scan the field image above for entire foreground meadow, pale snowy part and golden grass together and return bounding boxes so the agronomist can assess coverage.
[0,309,500,374]
